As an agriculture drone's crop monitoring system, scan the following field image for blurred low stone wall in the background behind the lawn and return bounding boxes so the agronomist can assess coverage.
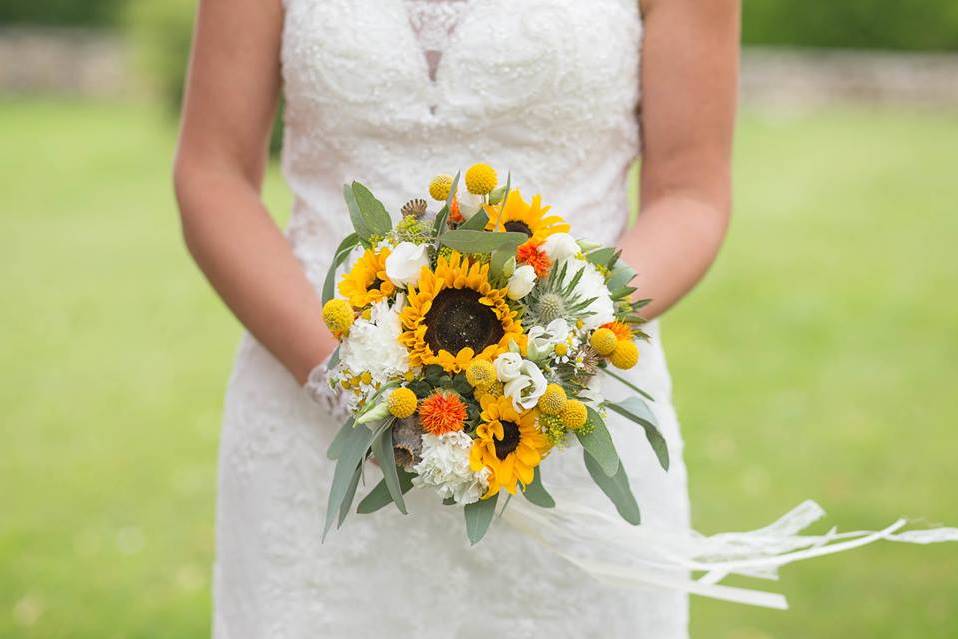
[0,27,958,107]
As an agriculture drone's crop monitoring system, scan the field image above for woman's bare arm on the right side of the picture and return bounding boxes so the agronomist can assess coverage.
[621,0,739,319]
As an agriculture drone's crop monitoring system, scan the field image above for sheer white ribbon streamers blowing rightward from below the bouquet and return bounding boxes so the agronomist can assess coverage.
[502,499,958,610]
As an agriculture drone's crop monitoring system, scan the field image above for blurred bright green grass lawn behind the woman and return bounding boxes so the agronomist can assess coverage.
[0,101,958,639]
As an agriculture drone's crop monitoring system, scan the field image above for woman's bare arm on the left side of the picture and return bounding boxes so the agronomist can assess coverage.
[174,0,333,382]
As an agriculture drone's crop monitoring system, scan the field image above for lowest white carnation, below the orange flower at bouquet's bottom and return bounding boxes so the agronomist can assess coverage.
[412,431,489,504]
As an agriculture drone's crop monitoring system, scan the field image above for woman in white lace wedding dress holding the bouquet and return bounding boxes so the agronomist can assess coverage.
[175,0,958,639]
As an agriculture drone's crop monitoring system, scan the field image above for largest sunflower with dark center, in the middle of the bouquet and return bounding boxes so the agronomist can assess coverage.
[399,252,523,373]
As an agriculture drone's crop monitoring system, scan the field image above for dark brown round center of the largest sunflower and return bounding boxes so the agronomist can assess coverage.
[425,288,505,354]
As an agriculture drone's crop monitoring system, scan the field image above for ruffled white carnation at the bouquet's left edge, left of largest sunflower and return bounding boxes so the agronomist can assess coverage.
[339,296,409,384]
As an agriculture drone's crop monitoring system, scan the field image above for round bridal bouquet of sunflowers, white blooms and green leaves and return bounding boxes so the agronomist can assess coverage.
[323,164,668,543]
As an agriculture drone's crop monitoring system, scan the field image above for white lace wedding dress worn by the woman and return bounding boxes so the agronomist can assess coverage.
[214,0,958,639]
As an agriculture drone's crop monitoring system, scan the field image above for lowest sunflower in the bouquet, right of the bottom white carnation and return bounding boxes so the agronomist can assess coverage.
[469,395,549,498]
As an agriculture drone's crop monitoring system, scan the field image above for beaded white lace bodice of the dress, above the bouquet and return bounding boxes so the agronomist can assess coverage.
[282,0,641,282]
